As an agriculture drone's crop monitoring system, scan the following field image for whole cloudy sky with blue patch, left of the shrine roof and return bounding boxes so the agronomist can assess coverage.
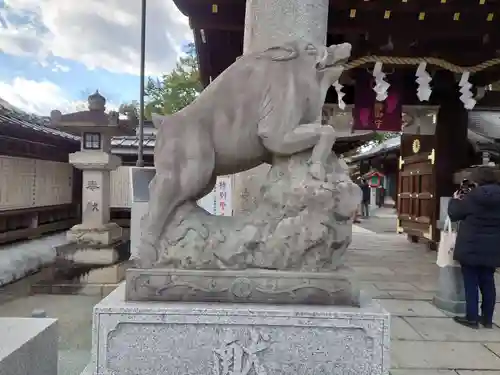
[0,0,192,115]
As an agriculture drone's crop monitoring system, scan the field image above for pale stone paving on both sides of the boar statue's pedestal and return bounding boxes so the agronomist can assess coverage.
[0,222,500,375]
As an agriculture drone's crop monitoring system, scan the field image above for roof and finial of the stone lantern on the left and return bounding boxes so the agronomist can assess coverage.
[50,91,138,136]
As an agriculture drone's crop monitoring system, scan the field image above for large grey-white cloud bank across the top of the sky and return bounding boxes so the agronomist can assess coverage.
[0,0,192,74]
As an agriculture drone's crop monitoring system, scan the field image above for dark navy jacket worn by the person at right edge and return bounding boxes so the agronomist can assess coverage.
[448,184,500,267]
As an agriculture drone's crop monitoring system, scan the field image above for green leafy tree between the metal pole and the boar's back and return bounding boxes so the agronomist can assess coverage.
[145,43,203,118]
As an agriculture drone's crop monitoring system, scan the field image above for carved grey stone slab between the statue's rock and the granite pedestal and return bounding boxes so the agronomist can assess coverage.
[126,267,360,306]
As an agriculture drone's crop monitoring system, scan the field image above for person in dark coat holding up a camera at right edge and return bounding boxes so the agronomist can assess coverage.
[448,167,500,328]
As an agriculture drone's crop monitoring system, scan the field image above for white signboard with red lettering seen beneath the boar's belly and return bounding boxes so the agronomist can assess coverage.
[198,176,233,216]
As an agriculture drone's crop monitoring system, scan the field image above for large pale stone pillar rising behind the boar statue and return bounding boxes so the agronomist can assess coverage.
[233,0,329,214]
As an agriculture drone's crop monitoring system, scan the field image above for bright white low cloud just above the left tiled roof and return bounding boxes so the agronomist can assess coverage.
[0,77,118,116]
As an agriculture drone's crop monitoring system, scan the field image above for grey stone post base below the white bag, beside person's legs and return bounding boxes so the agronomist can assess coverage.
[433,266,465,315]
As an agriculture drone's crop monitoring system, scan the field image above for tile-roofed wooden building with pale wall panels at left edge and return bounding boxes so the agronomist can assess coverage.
[0,99,82,246]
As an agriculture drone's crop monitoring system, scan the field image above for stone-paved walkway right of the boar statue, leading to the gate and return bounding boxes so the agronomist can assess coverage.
[347,231,500,375]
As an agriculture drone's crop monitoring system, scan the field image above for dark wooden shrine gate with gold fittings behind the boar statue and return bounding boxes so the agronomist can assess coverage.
[174,0,500,250]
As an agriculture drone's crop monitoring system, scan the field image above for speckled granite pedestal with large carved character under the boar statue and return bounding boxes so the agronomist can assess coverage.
[84,284,390,375]
